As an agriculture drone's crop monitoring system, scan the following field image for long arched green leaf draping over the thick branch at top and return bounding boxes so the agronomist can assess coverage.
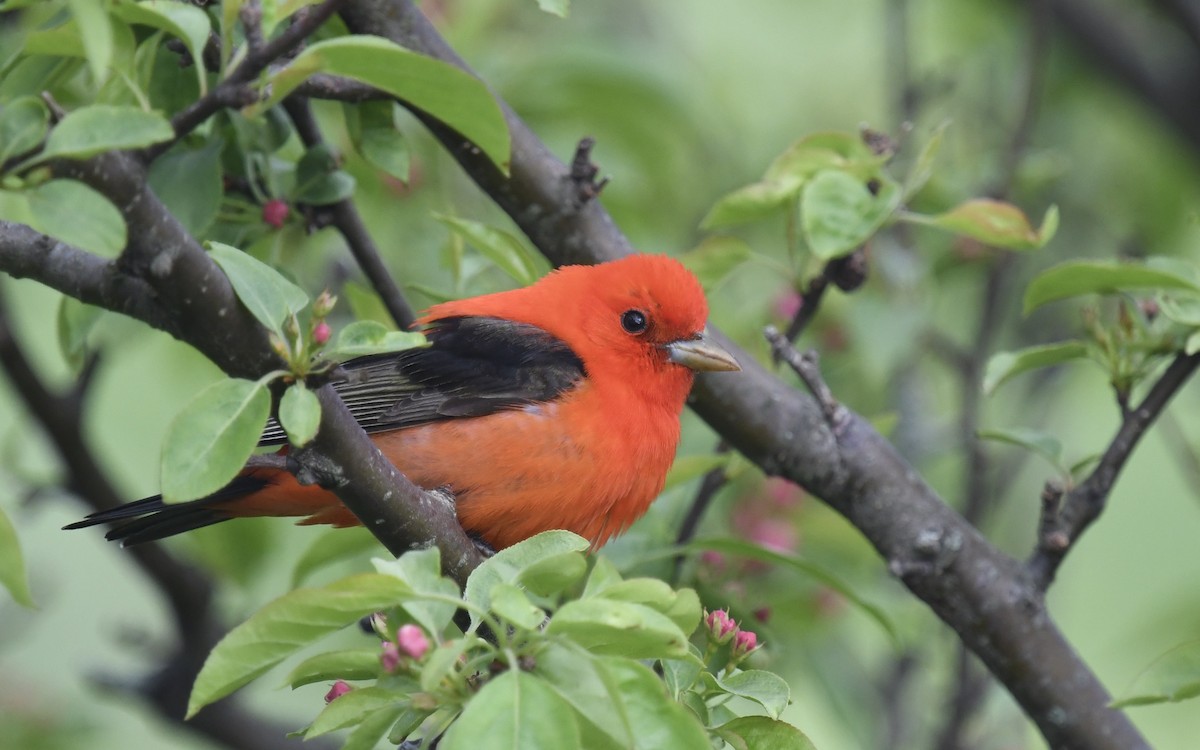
[259,36,510,174]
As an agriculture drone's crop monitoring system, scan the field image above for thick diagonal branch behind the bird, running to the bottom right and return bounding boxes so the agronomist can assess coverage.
[342,0,1146,750]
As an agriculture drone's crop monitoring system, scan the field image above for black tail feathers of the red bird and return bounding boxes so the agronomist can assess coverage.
[62,474,268,546]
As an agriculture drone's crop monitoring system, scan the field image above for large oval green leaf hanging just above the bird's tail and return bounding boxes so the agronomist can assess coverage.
[162,378,271,503]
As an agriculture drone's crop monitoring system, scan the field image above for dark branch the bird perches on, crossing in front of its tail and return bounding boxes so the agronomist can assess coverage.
[0,154,482,582]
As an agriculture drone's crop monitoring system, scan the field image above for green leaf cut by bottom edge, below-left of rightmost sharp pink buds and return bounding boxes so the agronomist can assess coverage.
[601,658,712,750]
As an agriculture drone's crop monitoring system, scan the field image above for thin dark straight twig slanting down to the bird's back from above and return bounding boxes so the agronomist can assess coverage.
[283,96,416,330]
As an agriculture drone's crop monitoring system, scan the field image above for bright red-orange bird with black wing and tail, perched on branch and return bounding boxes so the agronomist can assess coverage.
[66,256,739,550]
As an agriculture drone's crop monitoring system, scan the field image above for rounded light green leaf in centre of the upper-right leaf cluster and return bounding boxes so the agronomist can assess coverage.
[800,169,900,260]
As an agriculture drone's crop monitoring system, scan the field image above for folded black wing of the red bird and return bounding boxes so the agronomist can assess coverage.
[259,317,586,445]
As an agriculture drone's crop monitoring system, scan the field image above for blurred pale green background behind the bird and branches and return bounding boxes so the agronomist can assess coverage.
[0,0,1200,750]
